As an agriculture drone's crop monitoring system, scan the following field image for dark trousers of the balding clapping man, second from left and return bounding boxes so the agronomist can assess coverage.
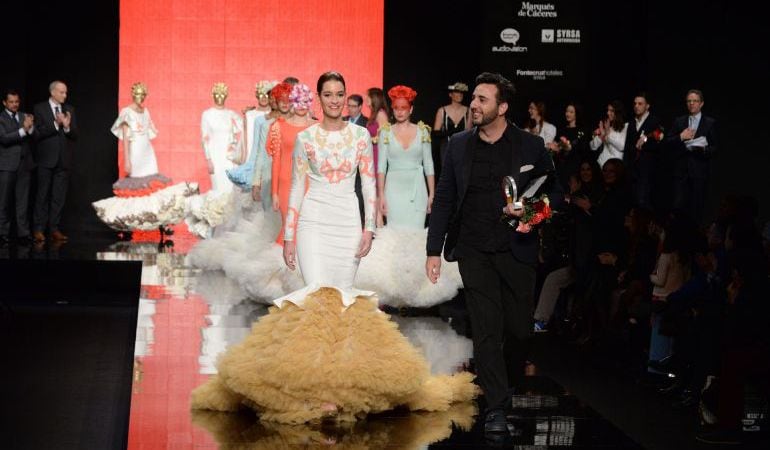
[32,164,69,231]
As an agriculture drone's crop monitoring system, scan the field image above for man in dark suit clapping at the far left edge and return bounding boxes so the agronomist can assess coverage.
[0,90,35,243]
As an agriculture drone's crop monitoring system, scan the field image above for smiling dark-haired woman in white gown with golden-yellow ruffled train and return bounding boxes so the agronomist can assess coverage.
[192,72,478,423]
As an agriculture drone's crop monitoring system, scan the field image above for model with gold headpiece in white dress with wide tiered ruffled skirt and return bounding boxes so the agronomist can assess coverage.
[93,83,198,234]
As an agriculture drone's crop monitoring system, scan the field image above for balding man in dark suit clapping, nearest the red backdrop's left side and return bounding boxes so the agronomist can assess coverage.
[32,81,77,242]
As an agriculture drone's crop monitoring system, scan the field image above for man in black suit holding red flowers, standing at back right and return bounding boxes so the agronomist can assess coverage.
[623,92,663,209]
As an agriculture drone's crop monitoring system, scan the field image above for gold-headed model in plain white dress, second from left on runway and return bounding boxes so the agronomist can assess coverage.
[201,83,244,194]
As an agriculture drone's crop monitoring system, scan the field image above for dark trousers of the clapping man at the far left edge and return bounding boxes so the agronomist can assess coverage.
[0,168,31,237]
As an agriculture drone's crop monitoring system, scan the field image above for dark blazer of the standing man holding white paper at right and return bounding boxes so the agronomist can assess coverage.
[666,114,718,178]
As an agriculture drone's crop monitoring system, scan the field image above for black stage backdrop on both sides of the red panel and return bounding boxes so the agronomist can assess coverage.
[0,0,770,232]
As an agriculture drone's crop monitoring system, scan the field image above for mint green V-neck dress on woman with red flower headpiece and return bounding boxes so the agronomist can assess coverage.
[377,122,434,230]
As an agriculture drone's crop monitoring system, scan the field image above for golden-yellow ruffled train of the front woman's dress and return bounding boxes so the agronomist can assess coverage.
[192,288,479,423]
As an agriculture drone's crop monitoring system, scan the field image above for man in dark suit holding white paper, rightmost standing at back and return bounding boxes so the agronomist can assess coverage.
[666,89,718,223]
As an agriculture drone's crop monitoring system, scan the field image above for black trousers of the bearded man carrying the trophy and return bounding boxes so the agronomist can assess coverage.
[458,248,535,409]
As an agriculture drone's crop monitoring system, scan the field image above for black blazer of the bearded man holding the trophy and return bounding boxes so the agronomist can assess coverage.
[426,123,564,264]
